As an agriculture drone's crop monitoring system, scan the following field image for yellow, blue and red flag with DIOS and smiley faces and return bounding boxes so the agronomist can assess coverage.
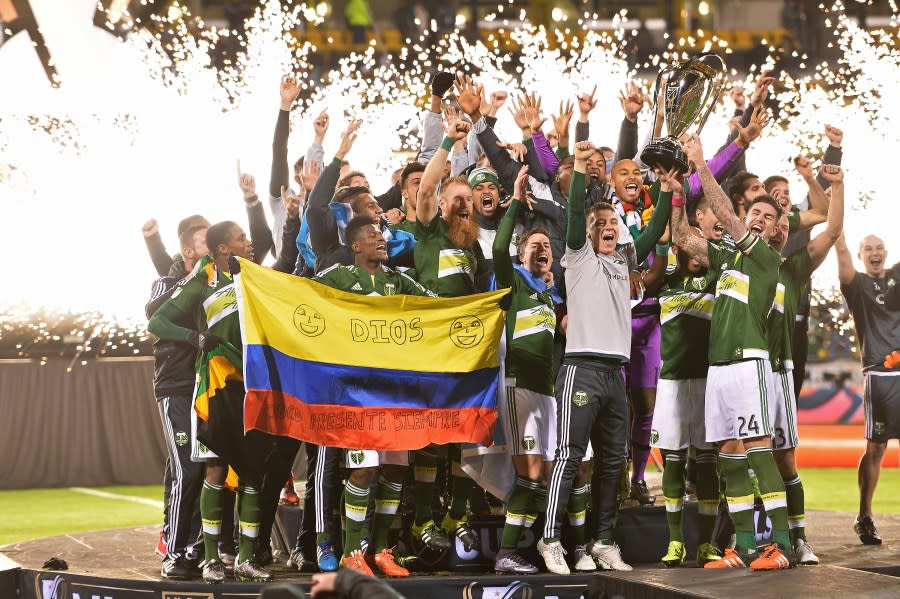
[236,260,508,450]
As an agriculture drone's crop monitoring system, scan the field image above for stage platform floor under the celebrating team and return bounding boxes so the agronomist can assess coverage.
[0,511,900,599]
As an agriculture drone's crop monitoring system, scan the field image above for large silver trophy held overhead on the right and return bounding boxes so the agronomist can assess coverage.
[641,52,726,173]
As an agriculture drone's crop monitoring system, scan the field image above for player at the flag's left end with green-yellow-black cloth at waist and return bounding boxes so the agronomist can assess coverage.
[148,221,272,583]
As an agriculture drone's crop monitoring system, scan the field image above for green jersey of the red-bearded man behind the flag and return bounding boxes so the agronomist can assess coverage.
[413,216,487,297]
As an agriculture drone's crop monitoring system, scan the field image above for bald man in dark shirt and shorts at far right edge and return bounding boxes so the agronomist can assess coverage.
[835,235,900,545]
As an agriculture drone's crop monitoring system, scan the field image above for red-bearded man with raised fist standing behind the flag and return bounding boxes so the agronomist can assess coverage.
[412,106,488,551]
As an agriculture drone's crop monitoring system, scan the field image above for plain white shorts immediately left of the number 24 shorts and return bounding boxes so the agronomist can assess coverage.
[650,379,715,451]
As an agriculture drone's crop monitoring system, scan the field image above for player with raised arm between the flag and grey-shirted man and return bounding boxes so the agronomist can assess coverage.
[492,166,568,574]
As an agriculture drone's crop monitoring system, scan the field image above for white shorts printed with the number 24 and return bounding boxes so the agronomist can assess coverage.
[705,359,774,443]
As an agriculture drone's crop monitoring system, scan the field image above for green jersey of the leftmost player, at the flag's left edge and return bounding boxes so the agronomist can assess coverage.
[169,261,243,352]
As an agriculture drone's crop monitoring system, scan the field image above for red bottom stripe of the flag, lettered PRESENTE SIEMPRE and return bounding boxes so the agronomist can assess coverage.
[244,389,497,451]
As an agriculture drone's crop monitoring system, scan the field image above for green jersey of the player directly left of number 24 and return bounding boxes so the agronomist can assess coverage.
[658,268,719,381]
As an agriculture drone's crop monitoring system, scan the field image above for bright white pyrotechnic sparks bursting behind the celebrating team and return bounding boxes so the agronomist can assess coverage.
[0,0,900,356]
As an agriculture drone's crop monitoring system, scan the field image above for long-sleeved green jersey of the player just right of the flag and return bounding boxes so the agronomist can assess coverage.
[492,200,556,395]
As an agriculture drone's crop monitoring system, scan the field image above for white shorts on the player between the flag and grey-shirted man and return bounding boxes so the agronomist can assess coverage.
[501,379,556,462]
